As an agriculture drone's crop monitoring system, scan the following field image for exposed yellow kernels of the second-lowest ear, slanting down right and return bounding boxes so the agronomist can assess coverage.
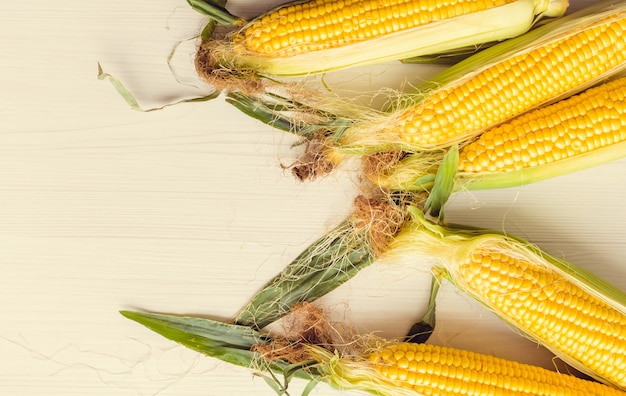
[455,247,626,388]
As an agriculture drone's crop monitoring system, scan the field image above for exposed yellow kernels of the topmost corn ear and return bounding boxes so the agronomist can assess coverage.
[240,0,516,56]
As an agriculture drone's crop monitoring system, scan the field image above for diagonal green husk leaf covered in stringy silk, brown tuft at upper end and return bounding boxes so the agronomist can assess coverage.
[235,194,414,328]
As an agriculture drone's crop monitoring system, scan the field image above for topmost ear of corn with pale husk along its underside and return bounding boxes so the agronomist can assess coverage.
[195,0,568,76]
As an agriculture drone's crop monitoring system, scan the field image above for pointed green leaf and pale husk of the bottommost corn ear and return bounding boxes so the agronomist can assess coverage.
[121,311,416,396]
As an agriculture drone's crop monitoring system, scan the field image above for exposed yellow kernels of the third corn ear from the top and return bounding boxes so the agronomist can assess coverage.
[458,78,626,173]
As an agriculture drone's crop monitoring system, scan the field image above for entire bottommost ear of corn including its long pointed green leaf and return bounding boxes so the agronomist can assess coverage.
[122,311,624,396]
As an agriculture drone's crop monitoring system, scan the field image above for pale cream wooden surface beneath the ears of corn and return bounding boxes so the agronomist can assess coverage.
[0,0,626,396]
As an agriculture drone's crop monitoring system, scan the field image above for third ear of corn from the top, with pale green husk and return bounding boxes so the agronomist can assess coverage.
[368,77,626,198]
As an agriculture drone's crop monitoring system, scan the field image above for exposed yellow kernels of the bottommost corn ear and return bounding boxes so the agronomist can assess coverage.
[369,343,624,396]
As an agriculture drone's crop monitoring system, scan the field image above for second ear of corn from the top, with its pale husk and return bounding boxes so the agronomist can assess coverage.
[338,0,626,153]
